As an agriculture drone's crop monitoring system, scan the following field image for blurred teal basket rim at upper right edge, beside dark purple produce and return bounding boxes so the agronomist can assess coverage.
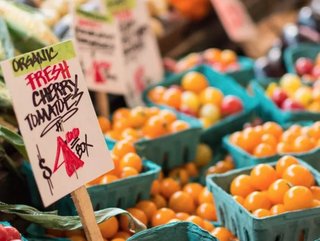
[284,43,320,74]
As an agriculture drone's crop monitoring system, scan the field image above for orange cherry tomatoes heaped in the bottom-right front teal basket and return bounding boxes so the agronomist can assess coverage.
[230,155,320,218]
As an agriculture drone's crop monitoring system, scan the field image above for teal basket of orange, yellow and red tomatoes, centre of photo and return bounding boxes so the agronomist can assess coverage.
[144,65,257,147]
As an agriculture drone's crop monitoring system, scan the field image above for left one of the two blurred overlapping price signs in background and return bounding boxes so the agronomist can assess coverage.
[72,8,127,94]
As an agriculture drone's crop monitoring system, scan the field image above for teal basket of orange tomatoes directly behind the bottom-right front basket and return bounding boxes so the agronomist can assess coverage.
[223,122,320,170]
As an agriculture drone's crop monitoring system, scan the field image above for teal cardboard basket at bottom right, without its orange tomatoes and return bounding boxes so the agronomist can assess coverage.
[207,161,320,241]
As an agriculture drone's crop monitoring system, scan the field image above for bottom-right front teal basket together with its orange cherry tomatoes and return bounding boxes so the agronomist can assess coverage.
[207,159,320,241]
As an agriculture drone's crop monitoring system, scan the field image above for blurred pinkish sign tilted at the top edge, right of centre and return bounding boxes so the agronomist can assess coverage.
[211,0,256,42]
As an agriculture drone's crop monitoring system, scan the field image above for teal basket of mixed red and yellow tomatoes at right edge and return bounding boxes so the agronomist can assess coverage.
[251,74,320,124]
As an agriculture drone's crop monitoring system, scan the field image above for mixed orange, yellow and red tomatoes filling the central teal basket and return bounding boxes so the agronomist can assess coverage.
[148,71,244,127]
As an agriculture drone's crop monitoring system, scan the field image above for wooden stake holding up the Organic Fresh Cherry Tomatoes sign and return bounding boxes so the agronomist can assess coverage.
[71,186,103,241]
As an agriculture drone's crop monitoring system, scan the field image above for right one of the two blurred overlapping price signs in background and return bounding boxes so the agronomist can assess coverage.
[105,0,164,106]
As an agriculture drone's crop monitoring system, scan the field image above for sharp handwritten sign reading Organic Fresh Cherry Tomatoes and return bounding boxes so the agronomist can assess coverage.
[1,41,113,206]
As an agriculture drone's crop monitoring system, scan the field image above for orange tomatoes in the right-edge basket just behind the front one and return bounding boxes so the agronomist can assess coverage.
[229,122,320,157]
